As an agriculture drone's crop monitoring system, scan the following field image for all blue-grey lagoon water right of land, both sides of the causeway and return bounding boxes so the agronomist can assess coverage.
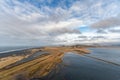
[40,48,120,80]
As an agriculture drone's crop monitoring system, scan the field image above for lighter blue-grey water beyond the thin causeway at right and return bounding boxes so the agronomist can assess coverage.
[88,48,120,65]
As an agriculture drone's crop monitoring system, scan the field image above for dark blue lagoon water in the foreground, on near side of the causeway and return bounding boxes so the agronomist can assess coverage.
[44,52,120,80]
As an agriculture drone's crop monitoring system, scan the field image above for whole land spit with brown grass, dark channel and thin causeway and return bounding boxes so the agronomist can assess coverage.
[0,46,119,80]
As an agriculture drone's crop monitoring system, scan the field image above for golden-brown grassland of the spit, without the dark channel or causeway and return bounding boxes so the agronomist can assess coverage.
[0,46,89,80]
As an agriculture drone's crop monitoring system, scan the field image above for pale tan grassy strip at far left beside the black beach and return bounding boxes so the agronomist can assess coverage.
[0,49,40,69]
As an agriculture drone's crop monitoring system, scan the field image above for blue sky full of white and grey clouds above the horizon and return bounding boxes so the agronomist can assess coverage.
[0,0,120,46]
